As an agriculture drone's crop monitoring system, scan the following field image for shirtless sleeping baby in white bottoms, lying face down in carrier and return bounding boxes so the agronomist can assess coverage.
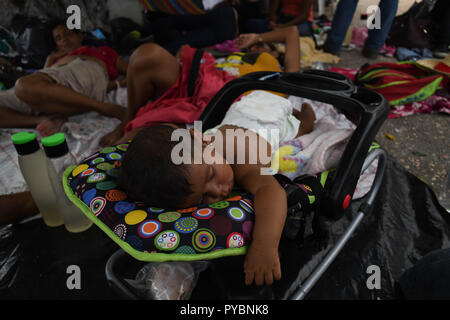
[118,91,315,285]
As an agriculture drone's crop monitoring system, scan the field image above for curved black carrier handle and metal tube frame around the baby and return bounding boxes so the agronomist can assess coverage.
[105,69,389,300]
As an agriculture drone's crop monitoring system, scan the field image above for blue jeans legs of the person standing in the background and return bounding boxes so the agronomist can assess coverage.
[324,0,398,54]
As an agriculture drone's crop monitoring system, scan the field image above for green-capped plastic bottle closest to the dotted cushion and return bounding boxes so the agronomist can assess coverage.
[42,133,92,232]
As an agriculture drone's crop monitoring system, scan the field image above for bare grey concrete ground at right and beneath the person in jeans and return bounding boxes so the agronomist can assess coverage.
[326,48,450,209]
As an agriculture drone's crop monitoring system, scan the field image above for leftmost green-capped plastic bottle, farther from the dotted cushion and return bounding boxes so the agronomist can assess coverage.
[11,132,64,227]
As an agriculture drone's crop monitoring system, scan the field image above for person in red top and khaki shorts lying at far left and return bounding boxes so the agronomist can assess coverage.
[0,23,128,136]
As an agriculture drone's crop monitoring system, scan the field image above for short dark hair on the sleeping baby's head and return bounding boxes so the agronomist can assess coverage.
[118,125,192,209]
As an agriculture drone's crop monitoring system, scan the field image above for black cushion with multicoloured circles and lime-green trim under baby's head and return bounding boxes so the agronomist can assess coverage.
[63,144,254,262]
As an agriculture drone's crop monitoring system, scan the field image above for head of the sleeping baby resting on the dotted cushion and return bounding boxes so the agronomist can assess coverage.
[118,125,234,209]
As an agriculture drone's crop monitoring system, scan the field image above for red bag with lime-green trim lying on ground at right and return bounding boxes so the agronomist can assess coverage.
[355,61,449,106]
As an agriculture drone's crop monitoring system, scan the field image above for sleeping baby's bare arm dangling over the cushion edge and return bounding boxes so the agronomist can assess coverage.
[219,125,287,285]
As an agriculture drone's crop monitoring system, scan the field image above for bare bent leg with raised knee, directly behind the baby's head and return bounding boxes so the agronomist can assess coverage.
[100,43,180,146]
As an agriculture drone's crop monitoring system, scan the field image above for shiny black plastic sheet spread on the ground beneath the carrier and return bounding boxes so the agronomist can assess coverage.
[0,158,450,300]
